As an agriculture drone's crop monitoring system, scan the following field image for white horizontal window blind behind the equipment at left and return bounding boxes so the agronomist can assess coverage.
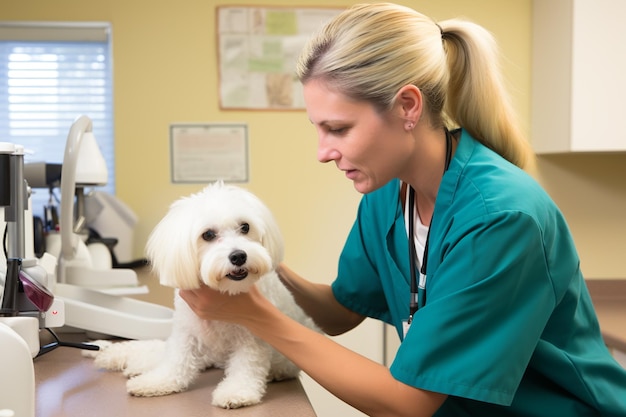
[0,22,115,216]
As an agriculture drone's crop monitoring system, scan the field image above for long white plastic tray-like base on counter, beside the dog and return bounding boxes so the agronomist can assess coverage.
[55,283,174,340]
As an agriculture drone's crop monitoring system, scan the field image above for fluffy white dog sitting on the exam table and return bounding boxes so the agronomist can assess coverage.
[85,182,317,408]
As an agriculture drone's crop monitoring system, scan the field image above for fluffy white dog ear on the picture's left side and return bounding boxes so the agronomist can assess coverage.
[146,198,200,289]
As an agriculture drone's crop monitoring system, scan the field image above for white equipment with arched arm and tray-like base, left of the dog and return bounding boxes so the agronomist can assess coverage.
[47,116,173,339]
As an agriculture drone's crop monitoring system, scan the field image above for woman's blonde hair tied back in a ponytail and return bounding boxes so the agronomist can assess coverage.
[296,3,533,168]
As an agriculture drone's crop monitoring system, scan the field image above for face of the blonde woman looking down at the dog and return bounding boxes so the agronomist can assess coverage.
[304,80,414,194]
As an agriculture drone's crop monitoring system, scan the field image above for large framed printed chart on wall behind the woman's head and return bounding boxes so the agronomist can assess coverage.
[217,6,342,110]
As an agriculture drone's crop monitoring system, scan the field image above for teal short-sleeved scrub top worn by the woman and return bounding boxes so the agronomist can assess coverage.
[332,131,626,417]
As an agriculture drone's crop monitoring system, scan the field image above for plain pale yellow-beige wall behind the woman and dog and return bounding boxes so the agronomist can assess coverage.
[0,0,626,281]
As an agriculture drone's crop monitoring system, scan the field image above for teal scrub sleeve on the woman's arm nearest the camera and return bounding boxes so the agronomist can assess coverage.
[391,212,555,405]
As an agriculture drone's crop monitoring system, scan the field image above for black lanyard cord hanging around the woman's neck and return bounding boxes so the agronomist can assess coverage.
[407,128,452,324]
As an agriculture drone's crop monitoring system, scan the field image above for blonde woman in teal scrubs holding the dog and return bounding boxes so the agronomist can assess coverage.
[181,4,626,417]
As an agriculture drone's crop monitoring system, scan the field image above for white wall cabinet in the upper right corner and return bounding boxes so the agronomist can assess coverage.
[531,0,626,154]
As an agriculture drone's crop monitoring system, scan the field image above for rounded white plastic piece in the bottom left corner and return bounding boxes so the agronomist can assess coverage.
[0,319,37,417]
